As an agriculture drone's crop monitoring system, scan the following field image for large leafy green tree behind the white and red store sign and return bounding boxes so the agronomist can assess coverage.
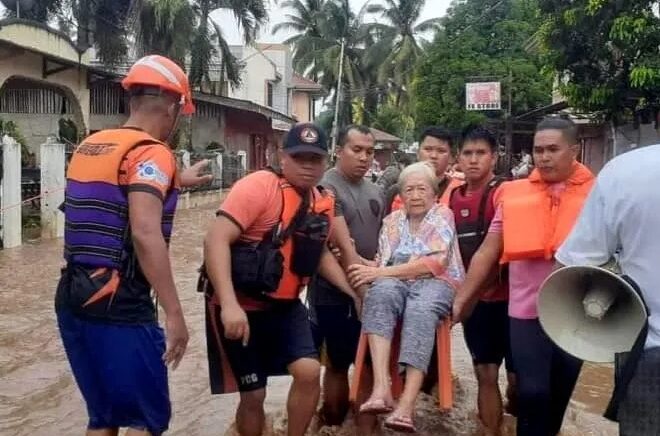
[413,0,552,130]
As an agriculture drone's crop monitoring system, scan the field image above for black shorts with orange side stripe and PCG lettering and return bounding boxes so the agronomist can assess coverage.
[206,300,318,394]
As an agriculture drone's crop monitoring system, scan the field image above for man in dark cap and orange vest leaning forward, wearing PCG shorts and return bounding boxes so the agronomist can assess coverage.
[203,123,353,436]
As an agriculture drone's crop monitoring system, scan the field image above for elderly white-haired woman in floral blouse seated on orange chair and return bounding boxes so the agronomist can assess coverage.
[349,162,465,432]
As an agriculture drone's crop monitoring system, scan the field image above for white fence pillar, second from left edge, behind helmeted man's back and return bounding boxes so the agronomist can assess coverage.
[41,137,66,239]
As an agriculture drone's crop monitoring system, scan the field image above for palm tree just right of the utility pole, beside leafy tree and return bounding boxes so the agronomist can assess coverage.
[367,0,439,106]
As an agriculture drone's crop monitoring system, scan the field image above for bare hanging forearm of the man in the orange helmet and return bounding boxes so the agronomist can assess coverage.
[133,233,181,316]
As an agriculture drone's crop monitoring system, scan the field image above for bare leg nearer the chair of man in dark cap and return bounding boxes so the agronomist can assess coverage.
[288,358,321,436]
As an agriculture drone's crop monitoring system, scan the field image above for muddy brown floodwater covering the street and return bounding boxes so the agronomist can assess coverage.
[0,207,617,436]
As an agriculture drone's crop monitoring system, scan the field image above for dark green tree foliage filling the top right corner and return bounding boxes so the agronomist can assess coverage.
[539,0,660,123]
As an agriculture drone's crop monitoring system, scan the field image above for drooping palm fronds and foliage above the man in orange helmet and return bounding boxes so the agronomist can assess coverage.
[13,0,268,87]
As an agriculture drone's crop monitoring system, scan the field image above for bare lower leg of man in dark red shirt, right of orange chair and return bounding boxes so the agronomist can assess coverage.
[474,364,502,436]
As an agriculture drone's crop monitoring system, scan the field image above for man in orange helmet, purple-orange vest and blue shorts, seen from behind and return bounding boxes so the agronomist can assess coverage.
[55,56,213,436]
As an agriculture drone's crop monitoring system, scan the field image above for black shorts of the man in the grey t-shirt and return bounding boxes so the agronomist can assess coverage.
[311,303,362,371]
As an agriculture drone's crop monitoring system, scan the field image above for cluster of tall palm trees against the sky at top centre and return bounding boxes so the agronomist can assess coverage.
[273,0,437,129]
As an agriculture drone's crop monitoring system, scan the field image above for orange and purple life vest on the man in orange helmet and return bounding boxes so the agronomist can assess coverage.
[64,128,178,270]
